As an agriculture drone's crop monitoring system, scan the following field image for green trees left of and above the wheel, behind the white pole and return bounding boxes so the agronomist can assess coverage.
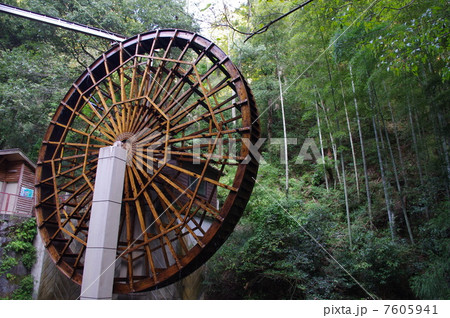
[0,0,199,160]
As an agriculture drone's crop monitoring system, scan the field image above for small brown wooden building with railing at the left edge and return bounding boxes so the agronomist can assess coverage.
[0,149,36,216]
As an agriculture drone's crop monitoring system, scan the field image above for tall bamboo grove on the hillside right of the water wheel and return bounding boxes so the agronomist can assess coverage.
[202,1,450,299]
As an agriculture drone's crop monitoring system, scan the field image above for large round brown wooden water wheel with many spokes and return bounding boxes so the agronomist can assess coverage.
[36,29,259,293]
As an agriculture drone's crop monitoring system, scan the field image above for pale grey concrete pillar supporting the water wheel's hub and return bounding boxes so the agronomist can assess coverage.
[80,142,127,299]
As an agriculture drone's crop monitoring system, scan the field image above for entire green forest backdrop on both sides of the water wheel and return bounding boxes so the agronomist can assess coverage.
[0,0,450,299]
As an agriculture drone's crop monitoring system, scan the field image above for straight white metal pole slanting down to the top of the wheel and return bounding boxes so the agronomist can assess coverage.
[0,4,126,42]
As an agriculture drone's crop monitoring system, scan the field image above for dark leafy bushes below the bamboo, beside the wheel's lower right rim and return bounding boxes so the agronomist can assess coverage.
[205,189,347,299]
